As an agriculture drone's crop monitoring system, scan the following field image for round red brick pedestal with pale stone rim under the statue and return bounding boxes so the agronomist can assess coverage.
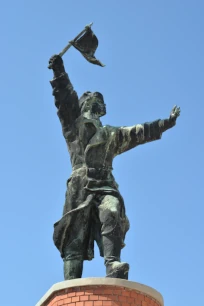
[36,278,164,306]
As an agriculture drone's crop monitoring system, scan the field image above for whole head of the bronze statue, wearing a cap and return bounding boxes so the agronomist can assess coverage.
[79,91,106,117]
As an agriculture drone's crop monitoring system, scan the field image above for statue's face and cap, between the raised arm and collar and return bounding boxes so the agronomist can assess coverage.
[82,92,106,117]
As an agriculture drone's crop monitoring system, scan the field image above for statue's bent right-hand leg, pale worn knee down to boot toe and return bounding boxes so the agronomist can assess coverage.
[98,195,129,279]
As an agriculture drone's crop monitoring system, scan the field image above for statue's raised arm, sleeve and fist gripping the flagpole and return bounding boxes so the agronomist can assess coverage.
[48,55,79,129]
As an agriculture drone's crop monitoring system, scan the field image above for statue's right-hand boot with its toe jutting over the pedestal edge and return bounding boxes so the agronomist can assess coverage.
[103,236,129,279]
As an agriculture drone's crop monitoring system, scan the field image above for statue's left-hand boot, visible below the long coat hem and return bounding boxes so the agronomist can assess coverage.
[64,259,83,280]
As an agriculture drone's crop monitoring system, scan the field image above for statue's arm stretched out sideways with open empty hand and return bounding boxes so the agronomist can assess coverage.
[115,106,180,155]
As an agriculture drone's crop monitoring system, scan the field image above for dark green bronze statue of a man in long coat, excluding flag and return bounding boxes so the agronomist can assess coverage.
[49,55,180,280]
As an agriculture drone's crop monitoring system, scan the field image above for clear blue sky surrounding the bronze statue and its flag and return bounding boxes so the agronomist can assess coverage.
[0,0,204,306]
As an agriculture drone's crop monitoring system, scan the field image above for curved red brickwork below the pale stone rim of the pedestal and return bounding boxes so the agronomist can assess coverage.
[42,286,161,306]
